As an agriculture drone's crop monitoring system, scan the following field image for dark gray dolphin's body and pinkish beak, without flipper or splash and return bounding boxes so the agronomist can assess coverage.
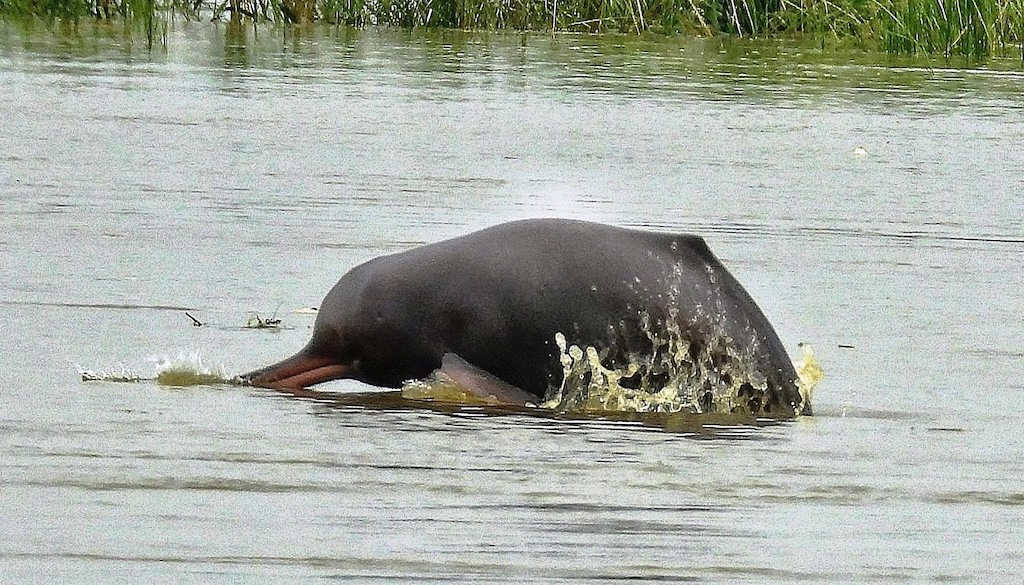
[241,219,810,417]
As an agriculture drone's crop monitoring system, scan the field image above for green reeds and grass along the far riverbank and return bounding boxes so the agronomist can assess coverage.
[0,0,1024,60]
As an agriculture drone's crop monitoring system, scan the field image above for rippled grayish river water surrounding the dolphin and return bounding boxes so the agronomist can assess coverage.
[0,18,1024,583]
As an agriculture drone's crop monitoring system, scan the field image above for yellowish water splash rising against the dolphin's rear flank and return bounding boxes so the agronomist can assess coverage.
[528,254,812,416]
